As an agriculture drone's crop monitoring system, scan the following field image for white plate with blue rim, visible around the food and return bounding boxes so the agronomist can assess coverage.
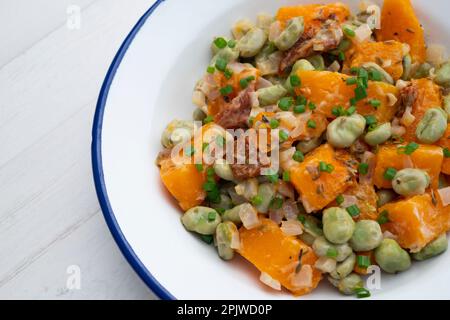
[92,0,450,299]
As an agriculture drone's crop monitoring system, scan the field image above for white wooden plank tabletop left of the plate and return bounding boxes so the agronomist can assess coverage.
[0,0,155,299]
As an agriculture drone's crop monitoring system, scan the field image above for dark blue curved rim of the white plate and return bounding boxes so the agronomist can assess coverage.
[91,0,176,300]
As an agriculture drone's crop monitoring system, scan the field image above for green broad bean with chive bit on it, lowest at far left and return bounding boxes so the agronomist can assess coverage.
[181,207,222,235]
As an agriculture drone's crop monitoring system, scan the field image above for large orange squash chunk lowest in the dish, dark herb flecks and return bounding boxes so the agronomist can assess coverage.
[239,219,322,296]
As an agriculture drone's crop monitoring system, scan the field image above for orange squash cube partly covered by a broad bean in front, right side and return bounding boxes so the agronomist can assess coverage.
[373,145,444,188]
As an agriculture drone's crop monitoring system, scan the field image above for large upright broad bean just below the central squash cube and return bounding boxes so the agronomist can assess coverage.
[322,207,355,244]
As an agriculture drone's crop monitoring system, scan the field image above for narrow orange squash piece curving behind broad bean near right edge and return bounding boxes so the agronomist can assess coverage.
[403,79,442,141]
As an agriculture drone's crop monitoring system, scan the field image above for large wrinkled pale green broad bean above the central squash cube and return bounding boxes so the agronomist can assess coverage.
[327,114,366,148]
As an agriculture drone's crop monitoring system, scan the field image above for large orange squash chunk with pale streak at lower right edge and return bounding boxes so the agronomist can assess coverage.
[379,193,450,252]
